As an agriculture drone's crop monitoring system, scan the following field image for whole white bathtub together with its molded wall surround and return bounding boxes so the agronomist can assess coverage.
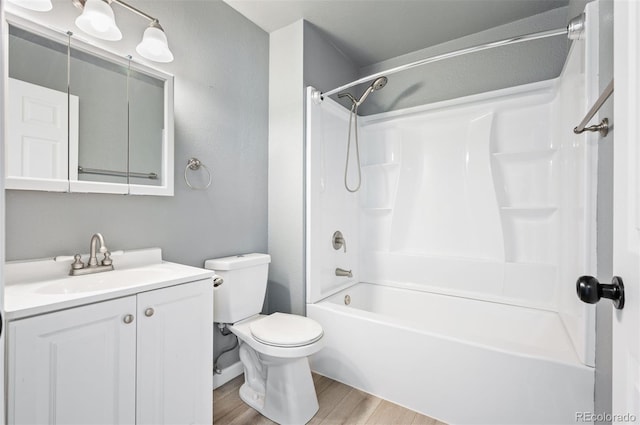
[306,2,599,423]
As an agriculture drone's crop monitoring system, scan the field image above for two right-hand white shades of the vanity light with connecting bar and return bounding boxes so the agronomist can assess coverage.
[72,0,173,62]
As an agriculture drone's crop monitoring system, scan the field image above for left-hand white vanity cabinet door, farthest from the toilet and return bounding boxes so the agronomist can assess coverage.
[8,297,136,424]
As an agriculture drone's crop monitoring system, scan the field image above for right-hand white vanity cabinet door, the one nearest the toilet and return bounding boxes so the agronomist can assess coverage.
[136,279,213,425]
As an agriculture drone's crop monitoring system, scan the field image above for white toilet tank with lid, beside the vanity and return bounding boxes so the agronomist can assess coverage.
[204,253,271,323]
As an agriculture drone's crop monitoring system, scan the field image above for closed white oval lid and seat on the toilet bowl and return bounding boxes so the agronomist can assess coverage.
[249,313,324,347]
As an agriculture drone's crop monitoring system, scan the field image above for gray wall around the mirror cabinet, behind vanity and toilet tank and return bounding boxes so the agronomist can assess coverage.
[5,0,269,367]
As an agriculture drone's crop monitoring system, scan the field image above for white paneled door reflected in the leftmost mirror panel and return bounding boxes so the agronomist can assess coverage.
[5,78,69,190]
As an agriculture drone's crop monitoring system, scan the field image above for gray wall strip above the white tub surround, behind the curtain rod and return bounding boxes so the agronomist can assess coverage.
[351,7,569,115]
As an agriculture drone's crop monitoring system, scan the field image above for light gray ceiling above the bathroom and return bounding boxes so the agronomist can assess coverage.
[225,0,569,67]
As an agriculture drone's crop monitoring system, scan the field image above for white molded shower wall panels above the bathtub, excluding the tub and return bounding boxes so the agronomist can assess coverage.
[307,73,591,311]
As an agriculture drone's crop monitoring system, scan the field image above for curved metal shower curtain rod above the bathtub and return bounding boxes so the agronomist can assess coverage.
[313,14,585,101]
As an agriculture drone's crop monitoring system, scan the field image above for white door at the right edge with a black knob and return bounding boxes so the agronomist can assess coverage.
[605,0,640,423]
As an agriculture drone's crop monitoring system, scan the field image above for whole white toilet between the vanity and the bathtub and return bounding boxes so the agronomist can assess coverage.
[205,254,323,425]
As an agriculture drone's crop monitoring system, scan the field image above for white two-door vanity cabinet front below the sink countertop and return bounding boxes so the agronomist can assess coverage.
[8,279,213,424]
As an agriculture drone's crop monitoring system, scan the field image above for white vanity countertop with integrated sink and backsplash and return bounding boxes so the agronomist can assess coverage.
[4,248,214,320]
